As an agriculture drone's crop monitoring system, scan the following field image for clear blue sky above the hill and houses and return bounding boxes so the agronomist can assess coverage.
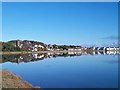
[2,2,118,45]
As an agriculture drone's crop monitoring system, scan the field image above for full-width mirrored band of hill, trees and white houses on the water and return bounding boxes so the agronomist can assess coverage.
[1,51,120,63]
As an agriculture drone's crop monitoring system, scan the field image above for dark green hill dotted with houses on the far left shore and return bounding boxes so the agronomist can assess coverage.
[0,40,46,51]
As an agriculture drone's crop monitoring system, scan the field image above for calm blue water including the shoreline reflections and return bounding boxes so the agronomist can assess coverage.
[2,53,118,88]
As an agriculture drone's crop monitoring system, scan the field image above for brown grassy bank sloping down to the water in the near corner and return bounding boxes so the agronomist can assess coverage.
[2,70,40,89]
